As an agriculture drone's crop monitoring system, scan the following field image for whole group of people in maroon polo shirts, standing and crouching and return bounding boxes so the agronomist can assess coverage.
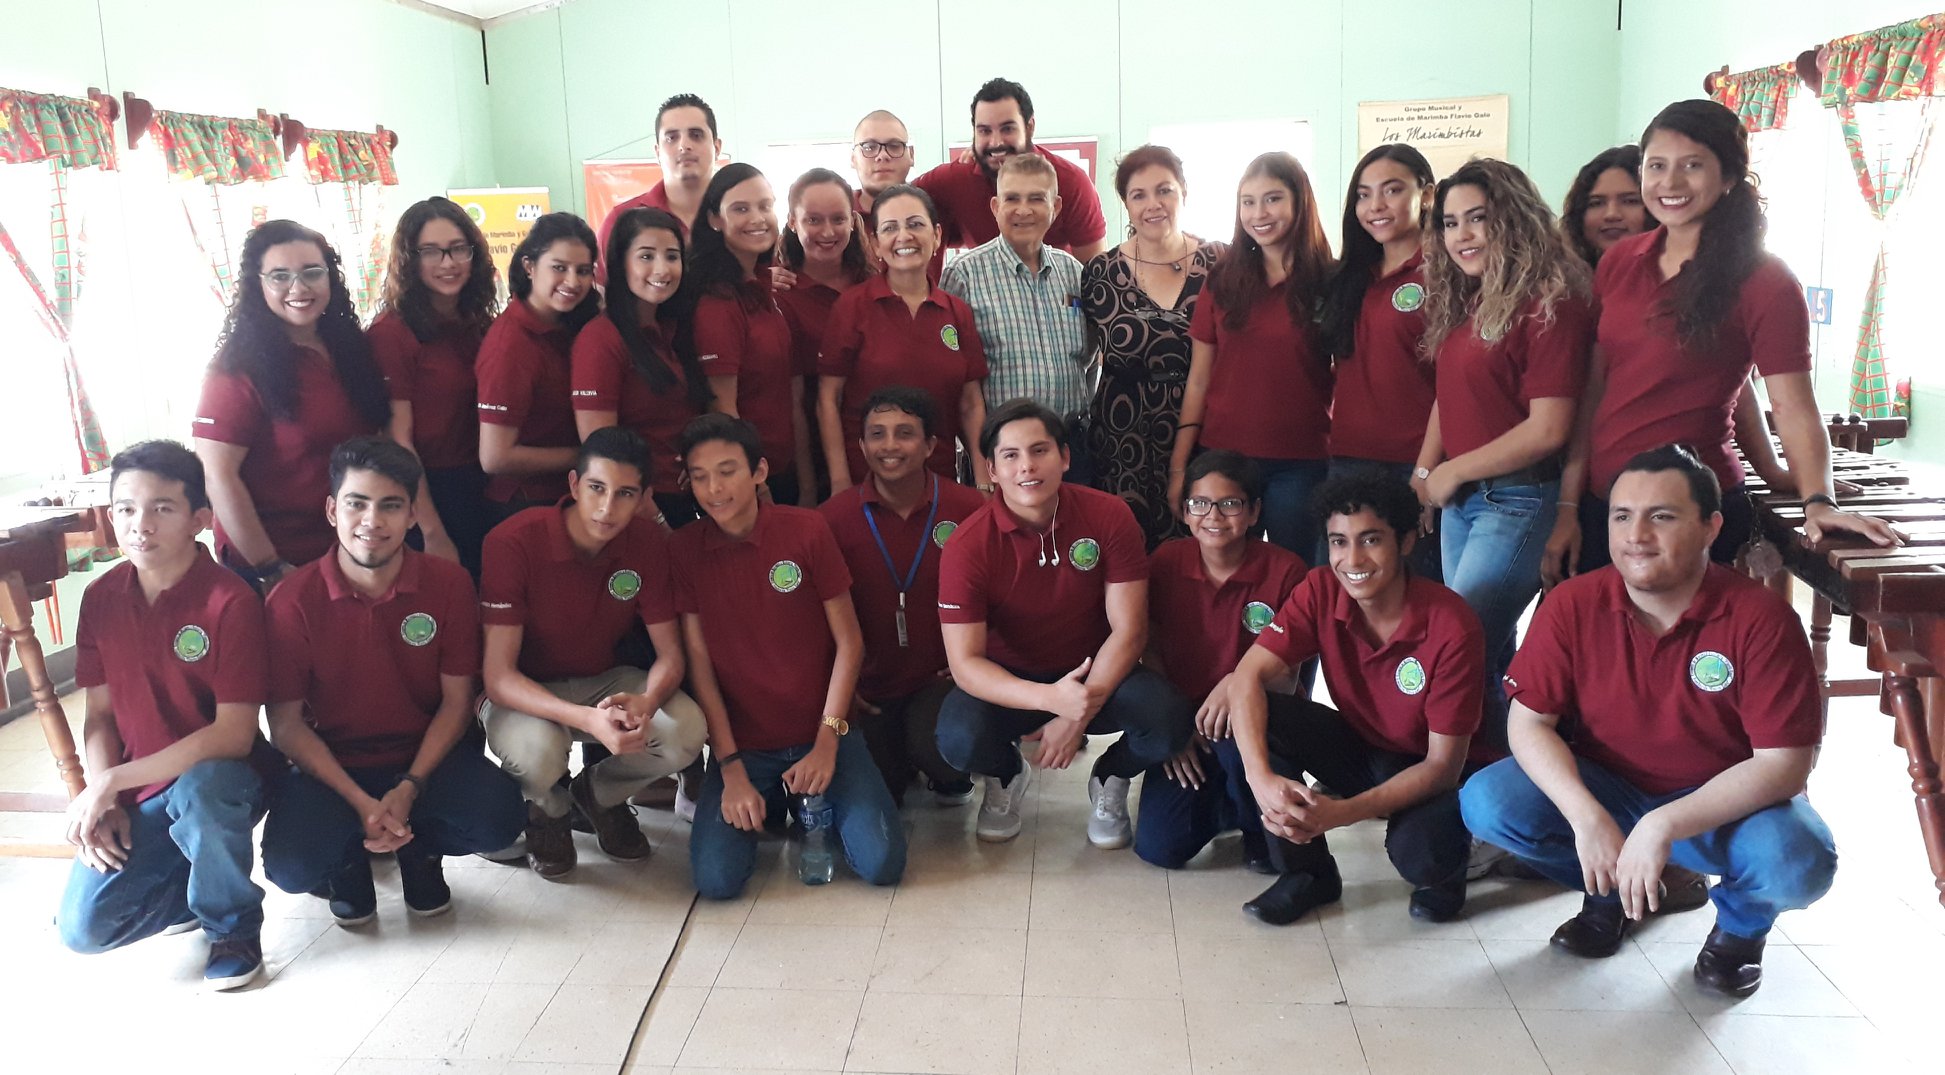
[62,80,1898,995]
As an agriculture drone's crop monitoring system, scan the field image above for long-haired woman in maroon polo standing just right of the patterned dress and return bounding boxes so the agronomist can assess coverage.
[1169,154,1332,560]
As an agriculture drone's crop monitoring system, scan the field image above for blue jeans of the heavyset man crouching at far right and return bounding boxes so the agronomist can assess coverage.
[1459,758,1836,937]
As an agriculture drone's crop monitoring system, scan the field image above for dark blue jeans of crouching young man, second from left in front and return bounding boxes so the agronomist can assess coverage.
[263,739,527,892]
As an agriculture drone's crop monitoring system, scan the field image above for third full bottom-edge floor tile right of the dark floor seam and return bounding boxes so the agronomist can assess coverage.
[1015,997,1190,1075]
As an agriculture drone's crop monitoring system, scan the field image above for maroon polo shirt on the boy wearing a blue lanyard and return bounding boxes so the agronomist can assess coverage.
[817,474,986,702]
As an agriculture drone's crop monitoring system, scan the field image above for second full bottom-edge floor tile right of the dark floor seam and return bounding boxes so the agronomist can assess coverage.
[844,993,1031,1075]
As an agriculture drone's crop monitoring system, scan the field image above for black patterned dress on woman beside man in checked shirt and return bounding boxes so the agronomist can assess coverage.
[1081,243,1225,550]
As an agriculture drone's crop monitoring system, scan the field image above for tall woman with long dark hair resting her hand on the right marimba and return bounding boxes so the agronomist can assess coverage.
[1544,99,1898,581]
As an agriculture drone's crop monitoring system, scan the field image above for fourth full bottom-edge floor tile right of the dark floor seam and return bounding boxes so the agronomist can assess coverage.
[1186,995,1365,1075]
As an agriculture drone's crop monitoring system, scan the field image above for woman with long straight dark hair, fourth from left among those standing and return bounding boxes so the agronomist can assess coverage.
[574,208,714,529]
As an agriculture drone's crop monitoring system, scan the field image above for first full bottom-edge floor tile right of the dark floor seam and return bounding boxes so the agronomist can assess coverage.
[677,989,864,1071]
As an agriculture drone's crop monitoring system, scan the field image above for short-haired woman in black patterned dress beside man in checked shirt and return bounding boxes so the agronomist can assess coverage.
[1081,146,1223,550]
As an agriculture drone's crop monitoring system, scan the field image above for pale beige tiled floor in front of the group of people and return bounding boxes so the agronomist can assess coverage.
[0,664,1945,1075]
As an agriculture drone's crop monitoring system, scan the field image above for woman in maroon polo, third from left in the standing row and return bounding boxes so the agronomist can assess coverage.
[477,212,601,519]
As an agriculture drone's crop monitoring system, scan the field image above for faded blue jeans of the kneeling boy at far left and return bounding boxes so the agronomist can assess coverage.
[60,758,263,954]
